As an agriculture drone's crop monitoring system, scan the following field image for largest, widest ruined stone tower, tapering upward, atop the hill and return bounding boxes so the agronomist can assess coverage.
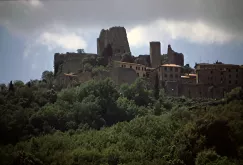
[97,27,131,55]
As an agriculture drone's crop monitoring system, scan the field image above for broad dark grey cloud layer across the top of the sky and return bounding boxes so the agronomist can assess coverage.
[0,0,243,35]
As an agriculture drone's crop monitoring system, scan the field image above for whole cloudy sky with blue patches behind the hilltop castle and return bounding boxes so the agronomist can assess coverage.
[0,0,243,82]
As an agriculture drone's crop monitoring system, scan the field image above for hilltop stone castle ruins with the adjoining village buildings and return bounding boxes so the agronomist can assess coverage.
[54,27,243,98]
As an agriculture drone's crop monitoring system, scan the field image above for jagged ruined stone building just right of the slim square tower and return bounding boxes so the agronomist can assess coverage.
[167,45,184,66]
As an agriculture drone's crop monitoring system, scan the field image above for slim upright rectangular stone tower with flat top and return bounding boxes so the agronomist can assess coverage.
[150,42,161,68]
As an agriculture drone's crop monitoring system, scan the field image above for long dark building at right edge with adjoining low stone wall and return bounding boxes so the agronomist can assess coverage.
[164,63,243,98]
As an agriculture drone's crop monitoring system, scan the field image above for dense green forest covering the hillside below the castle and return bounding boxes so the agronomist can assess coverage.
[0,71,243,165]
